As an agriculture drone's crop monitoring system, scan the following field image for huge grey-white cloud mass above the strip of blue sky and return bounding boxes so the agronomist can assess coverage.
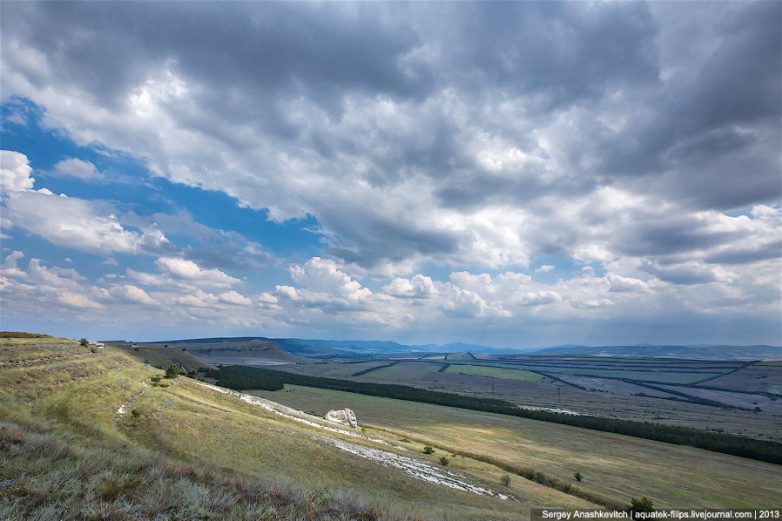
[0,2,782,272]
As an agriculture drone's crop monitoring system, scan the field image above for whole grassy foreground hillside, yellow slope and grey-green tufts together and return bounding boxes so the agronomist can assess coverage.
[0,339,590,519]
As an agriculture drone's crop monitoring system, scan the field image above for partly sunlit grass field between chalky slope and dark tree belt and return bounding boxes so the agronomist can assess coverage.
[257,385,782,508]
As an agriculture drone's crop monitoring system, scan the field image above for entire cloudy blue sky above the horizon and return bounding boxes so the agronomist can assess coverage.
[0,1,782,347]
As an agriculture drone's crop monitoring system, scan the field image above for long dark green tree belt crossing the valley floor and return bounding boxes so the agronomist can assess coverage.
[218,366,782,464]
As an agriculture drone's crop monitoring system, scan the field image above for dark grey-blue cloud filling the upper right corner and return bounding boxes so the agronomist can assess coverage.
[597,2,782,209]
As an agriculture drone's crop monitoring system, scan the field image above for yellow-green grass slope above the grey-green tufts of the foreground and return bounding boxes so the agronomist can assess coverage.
[0,336,572,519]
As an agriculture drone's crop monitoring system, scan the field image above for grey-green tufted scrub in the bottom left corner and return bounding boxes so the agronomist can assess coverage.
[0,422,422,521]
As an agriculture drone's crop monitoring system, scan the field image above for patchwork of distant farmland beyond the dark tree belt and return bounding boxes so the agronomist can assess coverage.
[280,353,782,439]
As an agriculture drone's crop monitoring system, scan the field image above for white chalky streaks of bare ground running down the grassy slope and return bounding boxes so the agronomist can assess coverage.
[196,381,518,501]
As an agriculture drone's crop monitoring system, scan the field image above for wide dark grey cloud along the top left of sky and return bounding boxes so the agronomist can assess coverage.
[3,2,427,121]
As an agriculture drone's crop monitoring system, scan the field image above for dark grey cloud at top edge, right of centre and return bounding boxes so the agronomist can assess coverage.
[422,2,658,110]
